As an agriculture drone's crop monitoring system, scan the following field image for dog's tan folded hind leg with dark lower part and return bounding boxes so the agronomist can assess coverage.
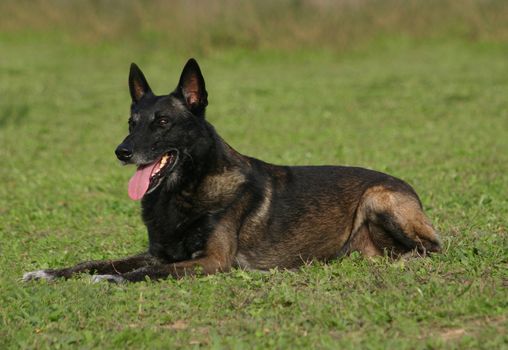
[351,186,441,257]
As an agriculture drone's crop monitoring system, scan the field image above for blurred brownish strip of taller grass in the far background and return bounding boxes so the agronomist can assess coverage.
[0,0,508,54]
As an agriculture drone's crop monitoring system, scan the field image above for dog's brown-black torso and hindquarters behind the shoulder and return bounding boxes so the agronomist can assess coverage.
[201,154,439,269]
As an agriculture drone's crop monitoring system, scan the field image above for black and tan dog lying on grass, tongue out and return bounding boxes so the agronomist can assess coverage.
[23,59,440,282]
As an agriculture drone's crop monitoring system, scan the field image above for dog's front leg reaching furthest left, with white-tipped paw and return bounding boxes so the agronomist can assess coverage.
[23,253,158,282]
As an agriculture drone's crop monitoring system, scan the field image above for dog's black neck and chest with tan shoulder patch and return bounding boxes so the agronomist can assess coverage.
[142,119,251,261]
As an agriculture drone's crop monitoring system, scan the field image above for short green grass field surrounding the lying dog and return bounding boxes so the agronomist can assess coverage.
[0,20,508,349]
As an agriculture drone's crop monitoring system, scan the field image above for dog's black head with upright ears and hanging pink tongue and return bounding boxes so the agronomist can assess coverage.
[115,59,211,200]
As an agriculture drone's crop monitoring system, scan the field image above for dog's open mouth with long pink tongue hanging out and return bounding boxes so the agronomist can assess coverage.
[129,150,178,200]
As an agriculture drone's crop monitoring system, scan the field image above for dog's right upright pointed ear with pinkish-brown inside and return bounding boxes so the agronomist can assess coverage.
[177,58,208,115]
